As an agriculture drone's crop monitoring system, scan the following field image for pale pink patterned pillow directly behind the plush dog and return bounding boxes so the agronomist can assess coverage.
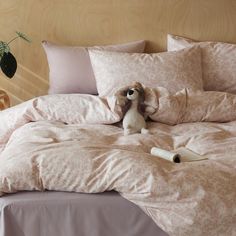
[89,47,202,96]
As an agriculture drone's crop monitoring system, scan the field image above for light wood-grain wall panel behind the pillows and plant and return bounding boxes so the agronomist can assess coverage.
[0,0,236,105]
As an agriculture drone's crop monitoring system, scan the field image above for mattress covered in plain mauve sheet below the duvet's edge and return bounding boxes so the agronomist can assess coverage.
[0,191,167,236]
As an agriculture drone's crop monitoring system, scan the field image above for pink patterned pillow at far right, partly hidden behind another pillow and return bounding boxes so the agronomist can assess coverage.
[168,35,236,94]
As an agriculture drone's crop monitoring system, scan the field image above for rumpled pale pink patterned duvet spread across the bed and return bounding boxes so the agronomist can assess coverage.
[0,90,236,236]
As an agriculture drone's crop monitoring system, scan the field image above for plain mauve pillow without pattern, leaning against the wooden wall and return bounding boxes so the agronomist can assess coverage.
[42,40,145,94]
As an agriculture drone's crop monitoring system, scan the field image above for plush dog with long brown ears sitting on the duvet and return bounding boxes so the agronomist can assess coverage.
[123,82,148,135]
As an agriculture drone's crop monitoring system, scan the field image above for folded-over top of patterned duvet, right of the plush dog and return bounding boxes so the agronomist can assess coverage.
[150,89,236,125]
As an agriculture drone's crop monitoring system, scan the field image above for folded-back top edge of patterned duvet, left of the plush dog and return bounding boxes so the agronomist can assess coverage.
[0,94,122,148]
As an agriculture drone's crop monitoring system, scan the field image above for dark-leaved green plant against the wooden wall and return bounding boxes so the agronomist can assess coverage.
[0,31,31,78]
